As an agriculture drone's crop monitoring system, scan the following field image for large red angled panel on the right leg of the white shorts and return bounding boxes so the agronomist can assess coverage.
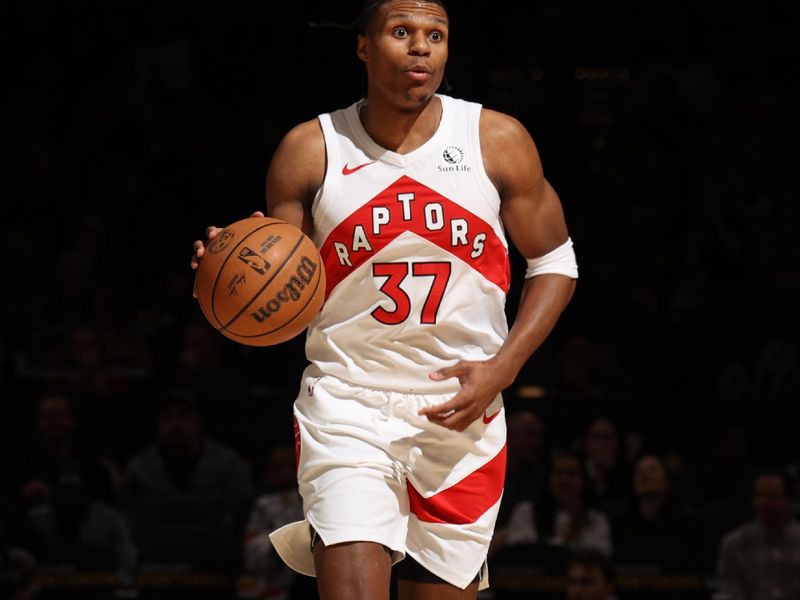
[407,446,506,525]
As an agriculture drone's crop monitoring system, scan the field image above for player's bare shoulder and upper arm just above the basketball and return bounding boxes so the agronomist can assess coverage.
[266,119,325,235]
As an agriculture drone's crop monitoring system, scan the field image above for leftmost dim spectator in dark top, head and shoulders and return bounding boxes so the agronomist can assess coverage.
[4,392,116,510]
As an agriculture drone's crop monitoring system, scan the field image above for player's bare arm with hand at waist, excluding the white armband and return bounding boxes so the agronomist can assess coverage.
[420,110,575,431]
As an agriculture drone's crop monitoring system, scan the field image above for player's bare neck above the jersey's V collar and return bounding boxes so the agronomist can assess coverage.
[359,96,443,154]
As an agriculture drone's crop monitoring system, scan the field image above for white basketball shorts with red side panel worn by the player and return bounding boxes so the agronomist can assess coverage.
[270,376,506,589]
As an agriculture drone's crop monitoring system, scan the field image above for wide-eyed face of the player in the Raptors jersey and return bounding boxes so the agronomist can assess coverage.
[358,0,448,110]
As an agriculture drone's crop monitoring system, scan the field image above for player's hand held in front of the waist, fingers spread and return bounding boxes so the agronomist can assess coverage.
[419,360,513,431]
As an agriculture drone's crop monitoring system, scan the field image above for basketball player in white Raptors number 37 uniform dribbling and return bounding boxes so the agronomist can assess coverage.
[192,0,577,600]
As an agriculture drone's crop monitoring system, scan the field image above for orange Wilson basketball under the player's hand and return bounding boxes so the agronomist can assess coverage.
[195,217,325,346]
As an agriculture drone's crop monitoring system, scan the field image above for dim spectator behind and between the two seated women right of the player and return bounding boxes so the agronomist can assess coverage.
[581,417,630,518]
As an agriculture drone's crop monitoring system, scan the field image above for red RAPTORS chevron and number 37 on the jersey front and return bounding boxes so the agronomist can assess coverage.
[320,176,510,325]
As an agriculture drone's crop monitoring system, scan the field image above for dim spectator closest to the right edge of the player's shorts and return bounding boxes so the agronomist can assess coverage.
[497,410,547,528]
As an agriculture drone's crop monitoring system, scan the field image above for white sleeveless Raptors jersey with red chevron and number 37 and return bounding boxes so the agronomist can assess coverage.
[306,95,510,393]
